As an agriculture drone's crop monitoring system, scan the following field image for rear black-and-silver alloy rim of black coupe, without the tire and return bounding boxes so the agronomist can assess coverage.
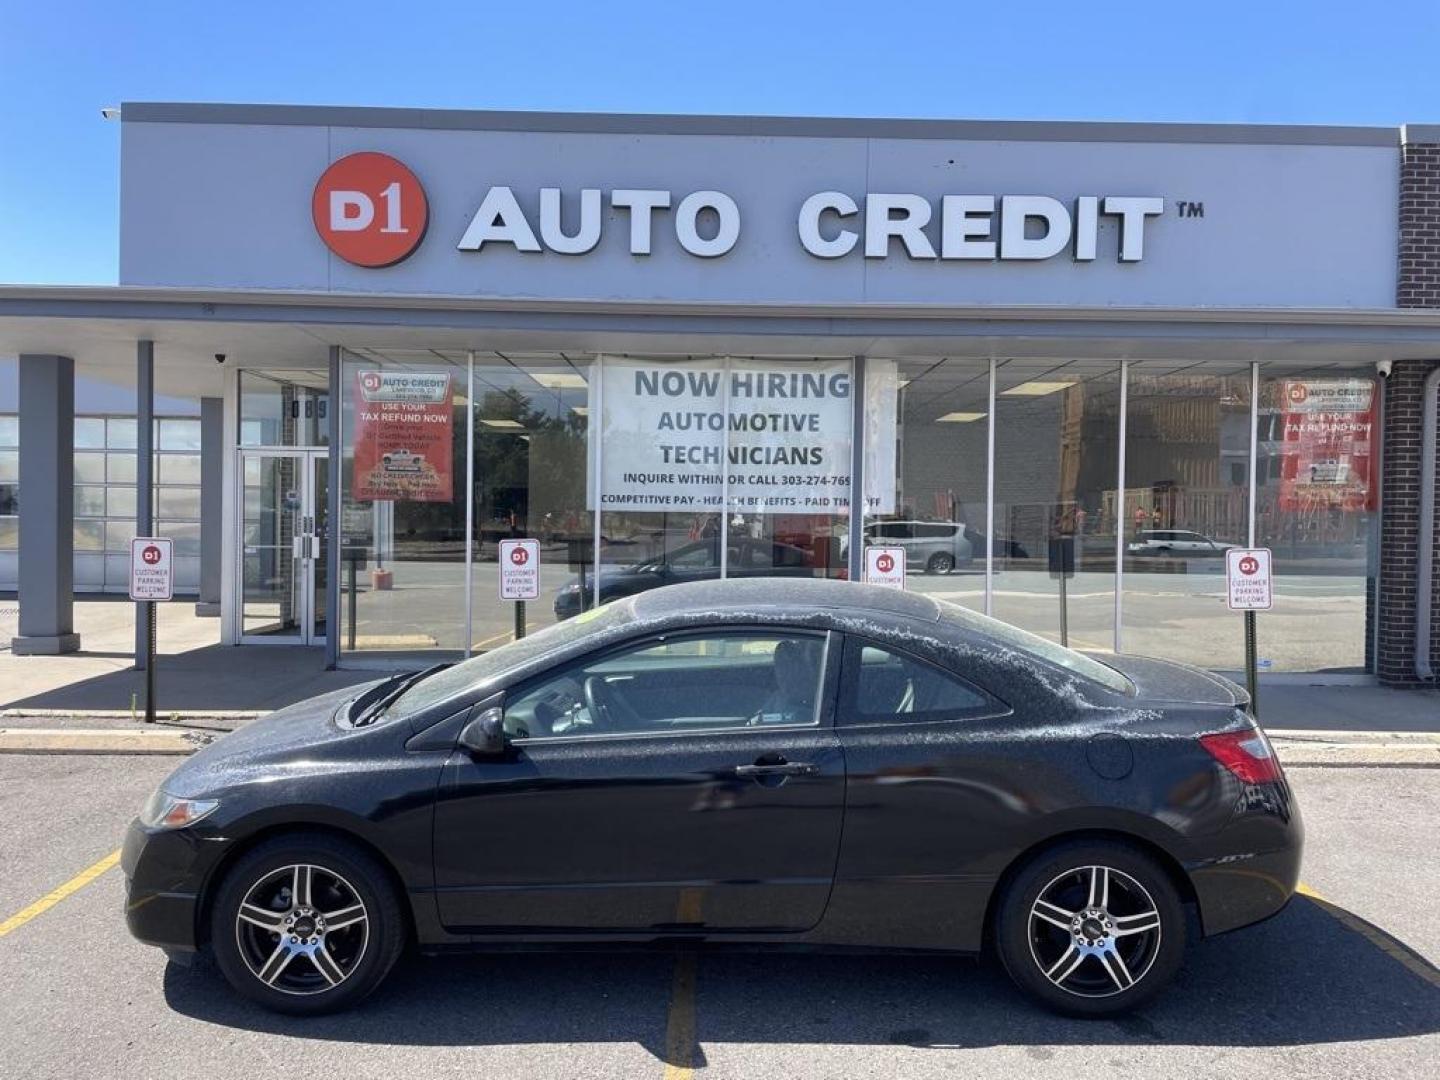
[1028,865,1161,998]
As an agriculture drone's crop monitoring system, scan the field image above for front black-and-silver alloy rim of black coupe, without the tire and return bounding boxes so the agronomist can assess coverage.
[235,863,370,995]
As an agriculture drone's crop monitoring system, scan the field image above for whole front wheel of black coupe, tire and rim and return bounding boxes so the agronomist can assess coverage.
[210,832,406,1015]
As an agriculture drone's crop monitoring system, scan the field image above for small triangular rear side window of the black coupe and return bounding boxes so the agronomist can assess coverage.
[841,639,1004,723]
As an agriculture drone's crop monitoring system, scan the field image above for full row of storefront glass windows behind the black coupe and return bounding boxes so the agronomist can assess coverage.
[318,350,1377,671]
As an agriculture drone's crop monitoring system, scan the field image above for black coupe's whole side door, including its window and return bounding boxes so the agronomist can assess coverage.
[435,626,845,935]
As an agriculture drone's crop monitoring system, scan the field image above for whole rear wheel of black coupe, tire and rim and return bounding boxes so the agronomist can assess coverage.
[995,841,1185,1017]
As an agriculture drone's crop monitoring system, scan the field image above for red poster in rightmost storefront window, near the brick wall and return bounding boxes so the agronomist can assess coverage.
[1279,379,1375,511]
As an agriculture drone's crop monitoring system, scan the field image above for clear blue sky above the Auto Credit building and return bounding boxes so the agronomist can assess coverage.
[0,0,1440,284]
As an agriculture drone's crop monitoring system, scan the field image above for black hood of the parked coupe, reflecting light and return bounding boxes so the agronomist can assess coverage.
[160,680,382,798]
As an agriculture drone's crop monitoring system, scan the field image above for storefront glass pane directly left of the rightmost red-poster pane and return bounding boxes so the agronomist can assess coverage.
[1120,361,1250,670]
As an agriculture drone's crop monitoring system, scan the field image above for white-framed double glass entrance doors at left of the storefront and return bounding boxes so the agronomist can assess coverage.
[239,451,330,645]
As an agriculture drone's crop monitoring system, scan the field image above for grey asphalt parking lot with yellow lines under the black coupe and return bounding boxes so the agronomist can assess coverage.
[0,756,1440,1080]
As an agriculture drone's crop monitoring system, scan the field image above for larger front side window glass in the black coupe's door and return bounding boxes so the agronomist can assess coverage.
[504,631,825,739]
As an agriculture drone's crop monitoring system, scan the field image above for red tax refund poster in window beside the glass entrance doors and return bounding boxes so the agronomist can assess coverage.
[351,372,454,503]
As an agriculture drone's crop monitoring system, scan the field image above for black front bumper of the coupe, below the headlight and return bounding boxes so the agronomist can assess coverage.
[120,821,225,952]
